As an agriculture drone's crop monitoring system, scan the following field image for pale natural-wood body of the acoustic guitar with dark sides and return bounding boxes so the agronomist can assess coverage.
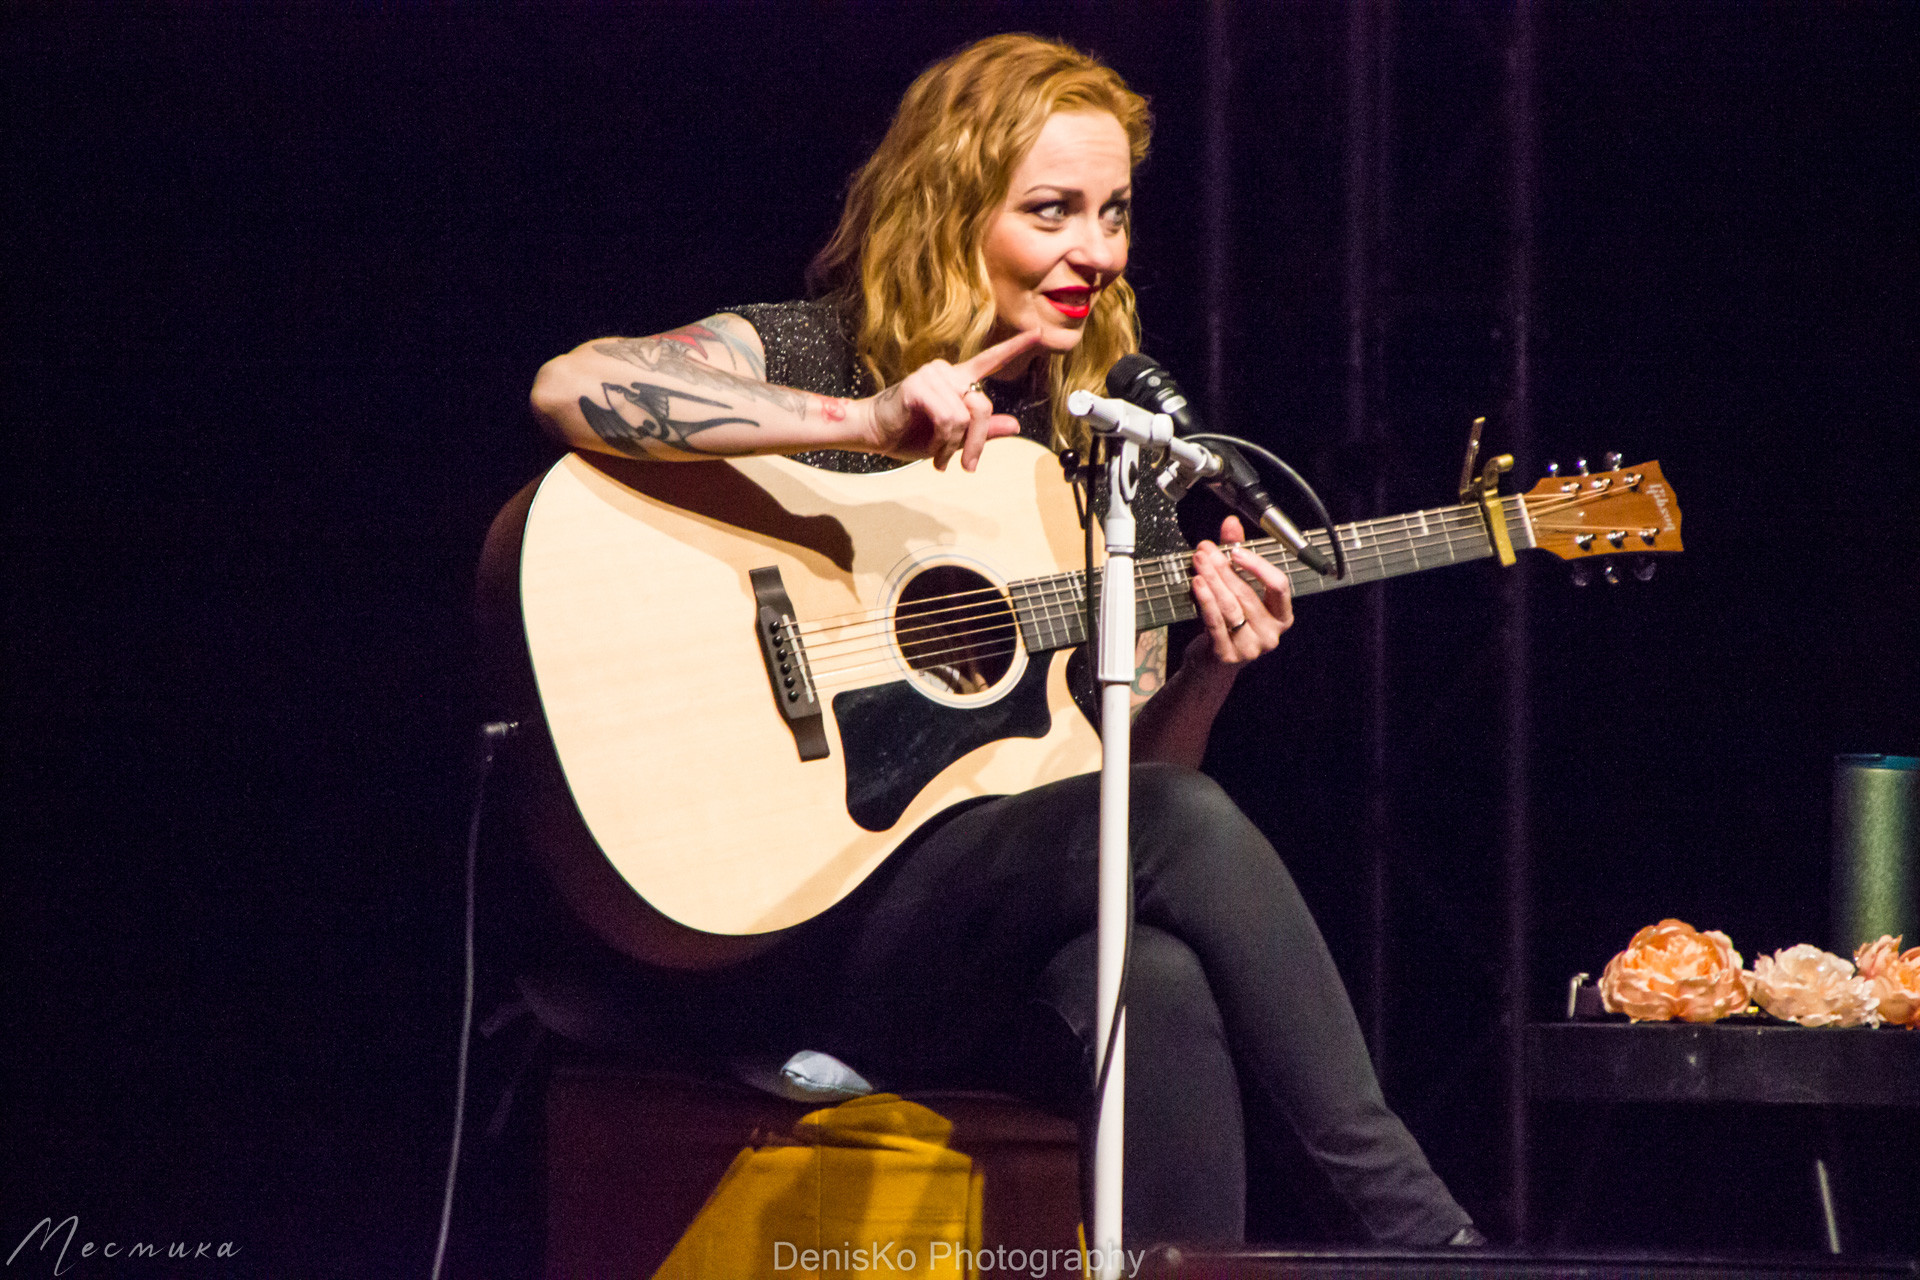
[482,439,1100,967]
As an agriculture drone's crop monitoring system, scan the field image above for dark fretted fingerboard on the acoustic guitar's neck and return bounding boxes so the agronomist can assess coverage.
[1012,495,1534,652]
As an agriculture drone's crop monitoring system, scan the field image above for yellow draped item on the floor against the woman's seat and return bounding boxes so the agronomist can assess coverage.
[653,1094,981,1280]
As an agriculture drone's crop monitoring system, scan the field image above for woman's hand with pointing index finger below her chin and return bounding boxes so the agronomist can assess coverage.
[862,330,1041,470]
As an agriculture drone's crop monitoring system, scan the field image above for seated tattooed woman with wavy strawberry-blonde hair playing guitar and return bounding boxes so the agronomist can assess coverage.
[534,36,1478,1245]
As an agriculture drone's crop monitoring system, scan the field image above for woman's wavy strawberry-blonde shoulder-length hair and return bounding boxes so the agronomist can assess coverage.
[806,35,1152,445]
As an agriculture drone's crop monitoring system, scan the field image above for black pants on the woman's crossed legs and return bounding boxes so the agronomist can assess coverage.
[755,766,1469,1245]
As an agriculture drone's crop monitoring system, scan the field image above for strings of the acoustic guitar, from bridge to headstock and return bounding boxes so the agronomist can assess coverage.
[799,493,1609,687]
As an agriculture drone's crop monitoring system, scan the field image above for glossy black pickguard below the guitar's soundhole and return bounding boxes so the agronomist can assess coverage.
[833,652,1052,831]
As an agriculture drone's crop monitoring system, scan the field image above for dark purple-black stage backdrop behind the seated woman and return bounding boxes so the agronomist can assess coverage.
[0,4,1920,1276]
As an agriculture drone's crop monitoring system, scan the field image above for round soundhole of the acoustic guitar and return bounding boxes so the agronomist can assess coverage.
[893,564,1020,695]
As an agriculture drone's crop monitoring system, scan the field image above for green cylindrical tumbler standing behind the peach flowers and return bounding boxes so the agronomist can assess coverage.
[1834,756,1920,956]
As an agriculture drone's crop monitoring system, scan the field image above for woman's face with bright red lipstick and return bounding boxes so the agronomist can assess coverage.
[981,111,1133,374]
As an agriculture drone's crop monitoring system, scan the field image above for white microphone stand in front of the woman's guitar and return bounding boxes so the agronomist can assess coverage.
[1068,391,1198,1280]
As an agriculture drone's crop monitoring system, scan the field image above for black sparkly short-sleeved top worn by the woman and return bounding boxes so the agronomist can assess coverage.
[722,301,1188,557]
